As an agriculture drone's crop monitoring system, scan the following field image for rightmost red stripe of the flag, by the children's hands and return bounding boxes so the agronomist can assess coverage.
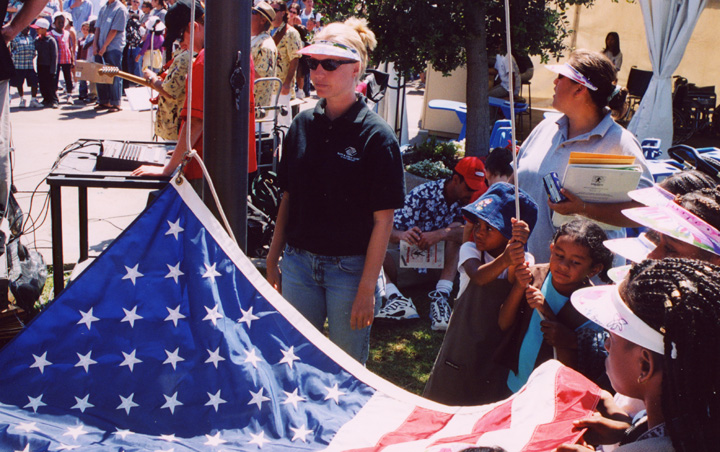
[523,367,600,452]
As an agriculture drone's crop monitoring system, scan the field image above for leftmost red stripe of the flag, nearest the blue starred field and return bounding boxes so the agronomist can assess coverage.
[346,407,453,452]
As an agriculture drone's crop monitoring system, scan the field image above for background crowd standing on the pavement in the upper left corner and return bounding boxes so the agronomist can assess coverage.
[6,0,180,112]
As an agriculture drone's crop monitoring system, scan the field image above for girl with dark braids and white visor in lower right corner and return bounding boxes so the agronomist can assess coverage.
[558,258,720,452]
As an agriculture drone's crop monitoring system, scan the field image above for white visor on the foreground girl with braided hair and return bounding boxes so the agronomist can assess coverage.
[571,285,665,355]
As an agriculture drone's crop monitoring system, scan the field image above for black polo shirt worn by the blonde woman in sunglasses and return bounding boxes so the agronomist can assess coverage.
[278,100,405,256]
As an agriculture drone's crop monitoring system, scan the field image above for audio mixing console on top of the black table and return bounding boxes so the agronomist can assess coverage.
[95,140,168,171]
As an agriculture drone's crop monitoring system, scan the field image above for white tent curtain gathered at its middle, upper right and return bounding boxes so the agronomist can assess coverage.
[628,0,707,158]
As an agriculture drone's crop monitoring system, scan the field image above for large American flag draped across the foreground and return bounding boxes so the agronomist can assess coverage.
[0,183,599,452]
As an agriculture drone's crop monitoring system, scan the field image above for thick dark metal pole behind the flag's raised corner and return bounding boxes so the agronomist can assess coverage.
[203,0,254,250]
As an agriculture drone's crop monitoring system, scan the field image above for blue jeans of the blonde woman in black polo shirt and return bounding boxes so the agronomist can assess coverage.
[280,245,378,364]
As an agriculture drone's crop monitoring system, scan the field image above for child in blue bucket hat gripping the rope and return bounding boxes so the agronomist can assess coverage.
[423,182,538,406]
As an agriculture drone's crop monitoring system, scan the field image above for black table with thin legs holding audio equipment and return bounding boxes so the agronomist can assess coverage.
[46,138,175,297]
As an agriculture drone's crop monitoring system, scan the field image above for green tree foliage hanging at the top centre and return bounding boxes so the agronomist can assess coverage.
[315,0,594,75]
